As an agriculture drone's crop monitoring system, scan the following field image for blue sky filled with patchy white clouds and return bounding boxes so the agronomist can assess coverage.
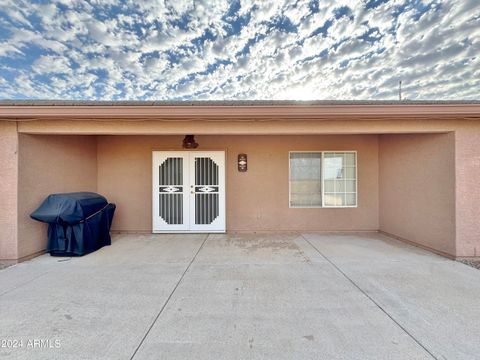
[0,0,480,100]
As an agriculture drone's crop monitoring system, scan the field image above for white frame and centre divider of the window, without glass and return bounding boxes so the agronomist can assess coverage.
[288,150,358,209]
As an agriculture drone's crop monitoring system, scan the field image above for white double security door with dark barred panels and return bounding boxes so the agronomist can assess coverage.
[152,151,225,233]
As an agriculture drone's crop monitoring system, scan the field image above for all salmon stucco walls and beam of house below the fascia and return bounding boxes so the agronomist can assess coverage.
[5,117,480,257]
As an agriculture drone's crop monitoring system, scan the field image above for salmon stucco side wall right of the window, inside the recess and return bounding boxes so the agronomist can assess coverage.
[379,133,456,256]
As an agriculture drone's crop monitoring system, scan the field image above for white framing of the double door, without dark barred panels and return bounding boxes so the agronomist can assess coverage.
[152,150,226,233]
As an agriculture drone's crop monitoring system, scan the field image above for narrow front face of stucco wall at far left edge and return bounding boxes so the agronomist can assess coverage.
[0,121,18,261]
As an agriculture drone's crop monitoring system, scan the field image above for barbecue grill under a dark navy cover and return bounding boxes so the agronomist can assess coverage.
[30,192,115,256]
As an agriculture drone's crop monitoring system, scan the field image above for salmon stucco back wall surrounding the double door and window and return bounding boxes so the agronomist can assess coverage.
[97,135,378,232]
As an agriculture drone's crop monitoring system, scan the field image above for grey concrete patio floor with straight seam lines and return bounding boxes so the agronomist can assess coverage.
[0,233,480,359]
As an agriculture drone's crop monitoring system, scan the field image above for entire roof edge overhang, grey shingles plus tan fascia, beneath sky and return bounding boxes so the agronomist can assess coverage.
[0,101,480,121]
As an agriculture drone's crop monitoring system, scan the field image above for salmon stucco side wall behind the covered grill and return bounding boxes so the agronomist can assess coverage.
[18,134,97,259]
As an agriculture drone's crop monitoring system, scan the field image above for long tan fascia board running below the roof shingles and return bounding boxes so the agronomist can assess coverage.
[0,104,480,120]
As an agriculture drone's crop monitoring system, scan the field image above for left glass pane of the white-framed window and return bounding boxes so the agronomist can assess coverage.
[290,153,322,206]
